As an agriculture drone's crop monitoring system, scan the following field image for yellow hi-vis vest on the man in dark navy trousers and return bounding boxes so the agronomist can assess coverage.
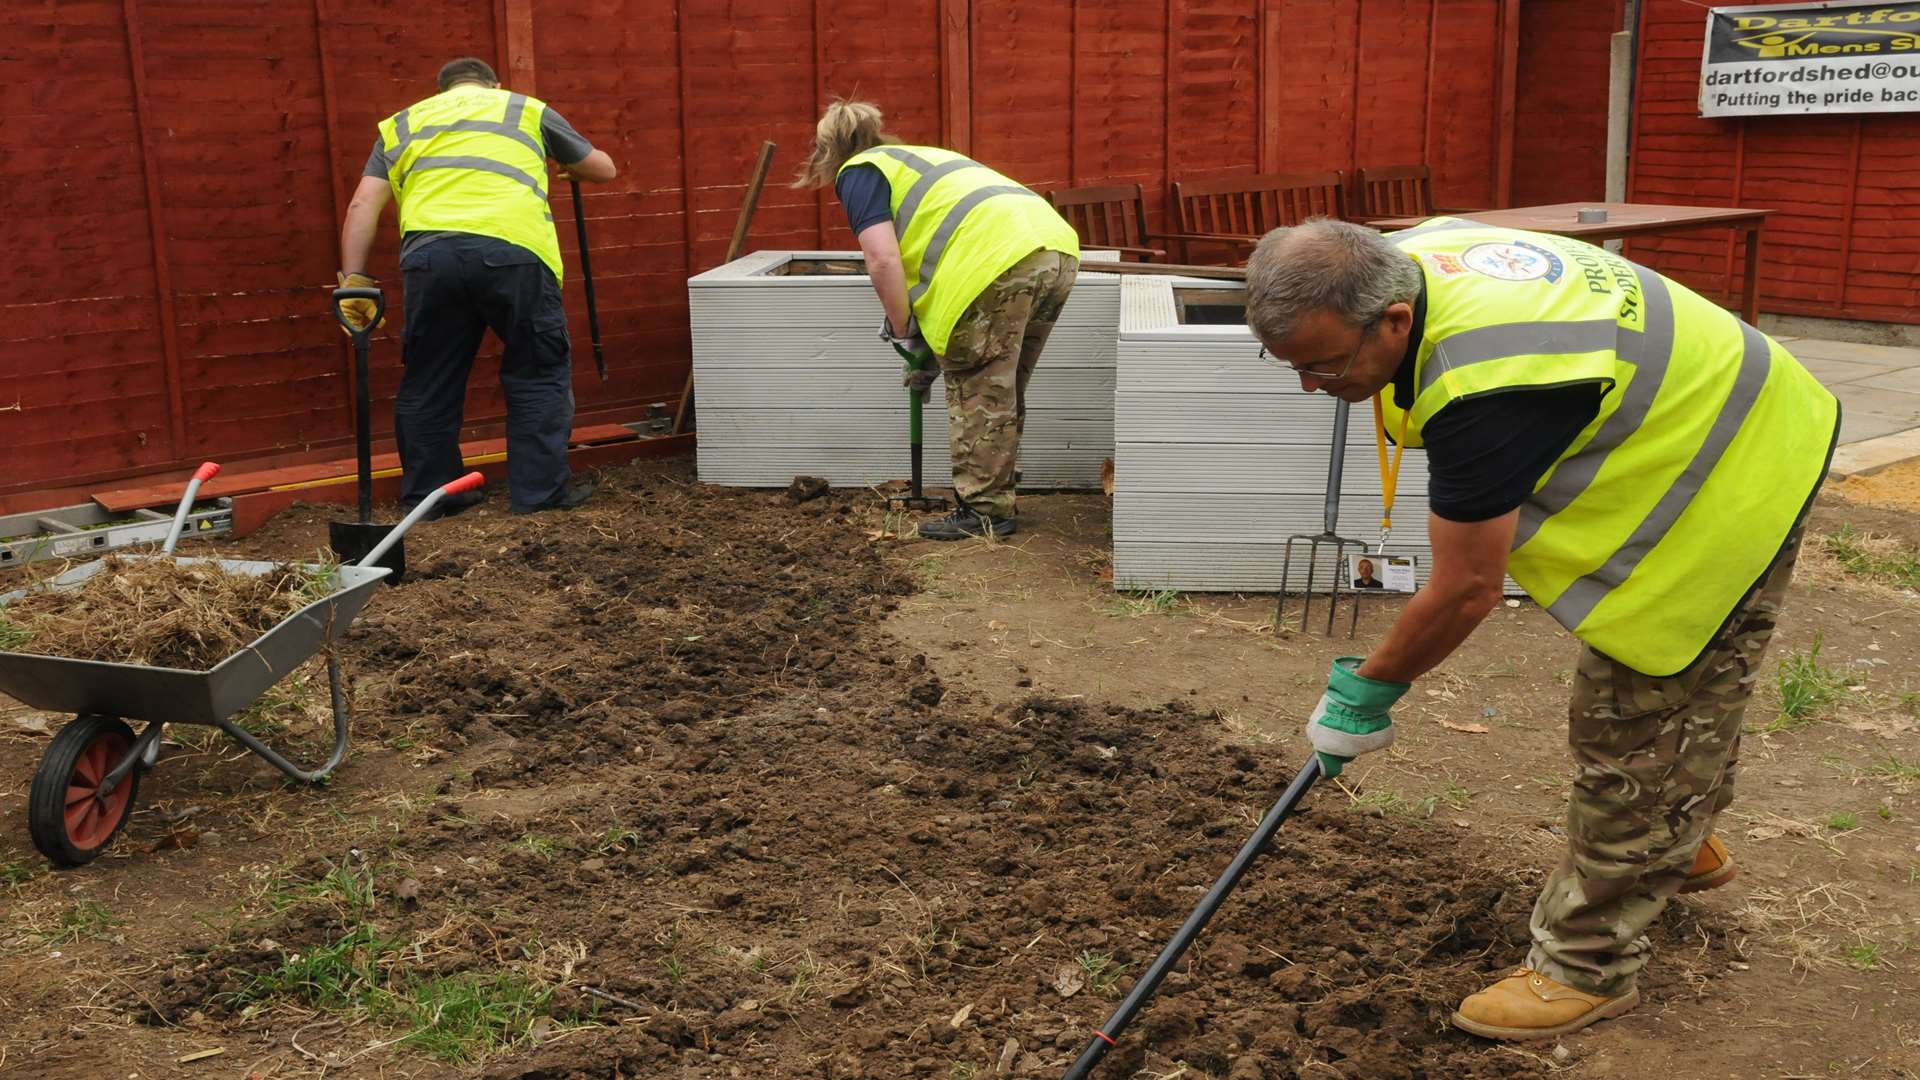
[380,85,563,281]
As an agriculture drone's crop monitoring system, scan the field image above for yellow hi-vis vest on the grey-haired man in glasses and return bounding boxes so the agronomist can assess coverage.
[1380,217,1839,676]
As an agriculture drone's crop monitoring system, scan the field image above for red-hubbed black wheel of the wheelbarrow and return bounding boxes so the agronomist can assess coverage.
[27,717,140,867]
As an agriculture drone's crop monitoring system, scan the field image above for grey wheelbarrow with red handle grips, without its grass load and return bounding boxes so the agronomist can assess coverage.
[0,461,486,867]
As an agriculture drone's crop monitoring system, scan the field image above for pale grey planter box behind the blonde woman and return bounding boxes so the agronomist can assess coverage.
[687,252,1121,490]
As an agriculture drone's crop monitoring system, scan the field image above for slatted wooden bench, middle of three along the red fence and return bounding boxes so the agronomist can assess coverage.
[1173,171,1346,261]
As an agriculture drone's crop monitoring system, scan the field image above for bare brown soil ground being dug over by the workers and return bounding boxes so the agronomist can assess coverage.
[0,455,1920,1080]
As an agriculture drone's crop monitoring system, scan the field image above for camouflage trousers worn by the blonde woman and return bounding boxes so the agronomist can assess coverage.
[941,250,1079,517]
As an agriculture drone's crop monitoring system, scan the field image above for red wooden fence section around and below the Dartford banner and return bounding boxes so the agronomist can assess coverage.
[1630,0,1920,323]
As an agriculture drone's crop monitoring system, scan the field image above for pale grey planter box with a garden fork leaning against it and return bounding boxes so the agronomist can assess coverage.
[1114,277,1430,592]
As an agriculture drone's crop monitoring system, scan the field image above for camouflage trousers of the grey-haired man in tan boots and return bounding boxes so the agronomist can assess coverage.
[1526,528,1801,995]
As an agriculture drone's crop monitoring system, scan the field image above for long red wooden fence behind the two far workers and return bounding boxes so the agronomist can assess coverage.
[0,0,1612,496]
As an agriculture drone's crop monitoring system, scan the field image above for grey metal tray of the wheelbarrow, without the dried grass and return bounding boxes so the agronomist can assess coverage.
[0,555,392,724]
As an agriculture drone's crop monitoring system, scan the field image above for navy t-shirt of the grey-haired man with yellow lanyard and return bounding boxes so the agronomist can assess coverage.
[1388,288,1601,523]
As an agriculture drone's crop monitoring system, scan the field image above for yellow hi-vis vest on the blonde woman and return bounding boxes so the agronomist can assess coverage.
[841,146,1079,356]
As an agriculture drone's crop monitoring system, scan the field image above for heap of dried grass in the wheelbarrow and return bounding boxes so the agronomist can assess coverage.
[0,555,332,671]
